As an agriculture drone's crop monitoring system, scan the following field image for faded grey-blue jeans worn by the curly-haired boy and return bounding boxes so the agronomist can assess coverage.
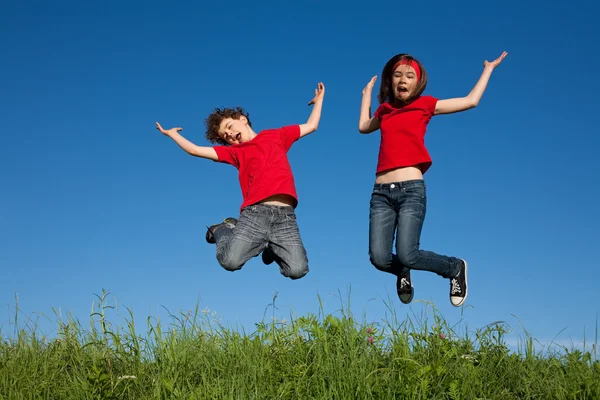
[213,203,308,279]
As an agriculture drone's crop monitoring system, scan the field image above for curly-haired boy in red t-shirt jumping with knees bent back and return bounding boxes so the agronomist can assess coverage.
[156,83,325,279]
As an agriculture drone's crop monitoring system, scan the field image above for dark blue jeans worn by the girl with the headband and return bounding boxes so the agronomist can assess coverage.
[369,180,460,278]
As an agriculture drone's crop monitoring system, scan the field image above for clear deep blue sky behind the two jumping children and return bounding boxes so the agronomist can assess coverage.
[0,1,600,348]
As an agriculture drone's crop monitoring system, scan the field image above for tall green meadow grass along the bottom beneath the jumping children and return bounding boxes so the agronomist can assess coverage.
[0,293,600,400]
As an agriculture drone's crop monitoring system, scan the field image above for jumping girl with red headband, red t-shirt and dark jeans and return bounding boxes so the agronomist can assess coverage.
[358,52,507,307]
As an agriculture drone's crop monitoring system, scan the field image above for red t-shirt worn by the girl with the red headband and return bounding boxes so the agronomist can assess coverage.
[374,96,437,174]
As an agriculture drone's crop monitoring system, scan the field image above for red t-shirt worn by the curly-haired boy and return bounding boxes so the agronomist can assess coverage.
[213,125,300,210]
